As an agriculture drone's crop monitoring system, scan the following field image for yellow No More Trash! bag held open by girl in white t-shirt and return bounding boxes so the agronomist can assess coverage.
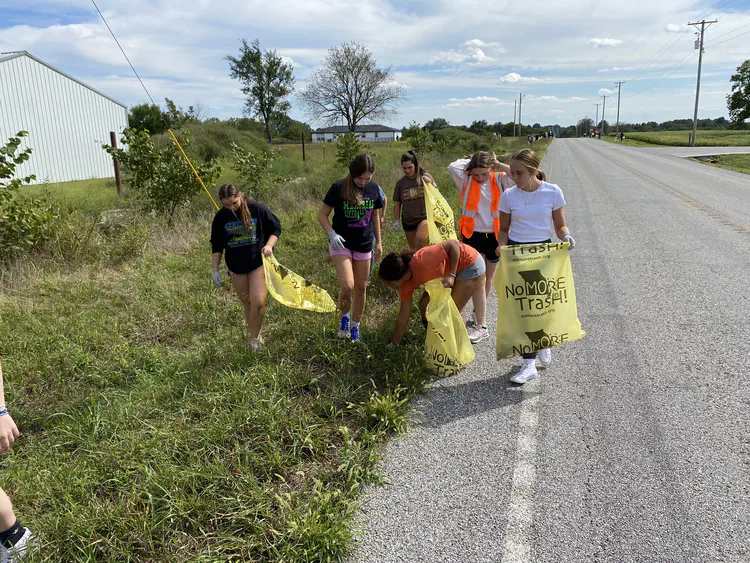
[493,242,586,360]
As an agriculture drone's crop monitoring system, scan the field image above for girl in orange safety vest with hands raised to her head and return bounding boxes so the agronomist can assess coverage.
[448,151,513,343]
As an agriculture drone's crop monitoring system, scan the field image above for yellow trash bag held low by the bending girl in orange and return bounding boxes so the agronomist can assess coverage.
[424,279,474,376]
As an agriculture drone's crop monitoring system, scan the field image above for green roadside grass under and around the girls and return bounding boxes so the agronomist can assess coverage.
[0,138,547,563]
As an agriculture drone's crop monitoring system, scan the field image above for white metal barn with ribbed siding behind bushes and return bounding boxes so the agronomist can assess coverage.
[0,51,128,183]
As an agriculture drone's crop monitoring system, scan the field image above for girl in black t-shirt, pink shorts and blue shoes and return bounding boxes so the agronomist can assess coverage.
[318,154,383,342]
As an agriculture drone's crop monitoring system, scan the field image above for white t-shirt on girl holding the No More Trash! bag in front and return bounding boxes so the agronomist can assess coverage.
[500,182,565,242]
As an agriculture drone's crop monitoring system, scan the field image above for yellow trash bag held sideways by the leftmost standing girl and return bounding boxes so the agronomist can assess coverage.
[263,255,336,313]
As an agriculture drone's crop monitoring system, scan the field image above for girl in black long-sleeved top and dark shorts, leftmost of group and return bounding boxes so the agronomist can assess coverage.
[211,184,281,352]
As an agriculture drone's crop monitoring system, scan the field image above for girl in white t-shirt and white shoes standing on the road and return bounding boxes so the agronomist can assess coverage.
[496,149,576,383]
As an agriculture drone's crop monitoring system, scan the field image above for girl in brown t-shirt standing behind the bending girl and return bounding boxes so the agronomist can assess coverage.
[393,151,435,250]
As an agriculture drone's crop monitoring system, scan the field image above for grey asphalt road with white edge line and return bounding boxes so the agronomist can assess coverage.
[352,139,750,563]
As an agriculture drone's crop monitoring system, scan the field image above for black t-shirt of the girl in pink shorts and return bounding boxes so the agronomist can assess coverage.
[323,180,383,252]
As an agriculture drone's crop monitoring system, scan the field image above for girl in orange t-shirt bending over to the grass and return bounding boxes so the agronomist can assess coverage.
[379,240,487,346]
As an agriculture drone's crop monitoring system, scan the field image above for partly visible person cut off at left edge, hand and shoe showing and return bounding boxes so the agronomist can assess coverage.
[0,364,35,563]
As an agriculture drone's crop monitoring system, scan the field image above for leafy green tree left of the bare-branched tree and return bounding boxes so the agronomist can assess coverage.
[225,39,294,143]
